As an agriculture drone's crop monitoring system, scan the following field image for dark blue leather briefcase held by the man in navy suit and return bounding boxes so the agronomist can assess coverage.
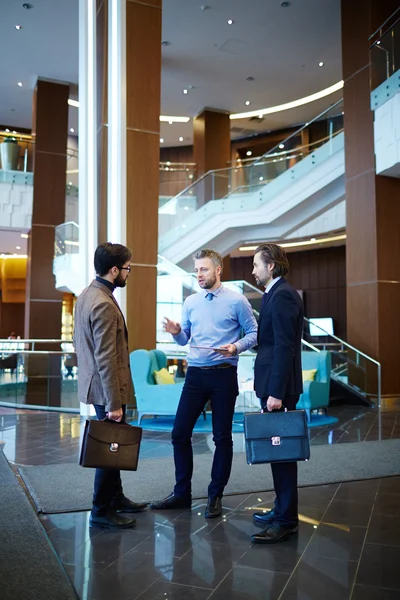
[244,410,310,465]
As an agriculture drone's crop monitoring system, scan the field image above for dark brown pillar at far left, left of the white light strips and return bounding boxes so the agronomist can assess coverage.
[25,79,69,406]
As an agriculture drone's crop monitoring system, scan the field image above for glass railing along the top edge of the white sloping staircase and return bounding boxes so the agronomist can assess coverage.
[158,100,343,246]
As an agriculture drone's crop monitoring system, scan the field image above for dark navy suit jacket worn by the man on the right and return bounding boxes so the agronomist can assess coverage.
[254,277,304,409]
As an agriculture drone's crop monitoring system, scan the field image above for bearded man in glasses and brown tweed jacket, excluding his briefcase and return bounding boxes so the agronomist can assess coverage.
[74,243,146,528]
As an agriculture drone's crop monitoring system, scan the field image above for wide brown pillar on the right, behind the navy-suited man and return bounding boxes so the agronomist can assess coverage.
[342,0,400,404]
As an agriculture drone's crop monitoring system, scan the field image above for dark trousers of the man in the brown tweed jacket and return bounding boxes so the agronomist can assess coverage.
[92,404,126,515]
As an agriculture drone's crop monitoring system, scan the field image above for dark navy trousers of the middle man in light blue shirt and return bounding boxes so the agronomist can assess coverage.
[172,367,239,498]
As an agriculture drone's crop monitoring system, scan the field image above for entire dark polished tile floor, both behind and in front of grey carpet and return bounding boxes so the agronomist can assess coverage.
[0,406,400,600]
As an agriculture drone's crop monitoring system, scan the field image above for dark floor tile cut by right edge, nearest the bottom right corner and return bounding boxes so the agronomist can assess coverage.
[357,543,400,591]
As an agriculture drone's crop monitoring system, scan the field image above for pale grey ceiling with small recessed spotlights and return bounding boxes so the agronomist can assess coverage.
[0,0,342,146]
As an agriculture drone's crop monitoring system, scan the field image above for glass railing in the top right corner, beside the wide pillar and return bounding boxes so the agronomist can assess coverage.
[369,8,400,91]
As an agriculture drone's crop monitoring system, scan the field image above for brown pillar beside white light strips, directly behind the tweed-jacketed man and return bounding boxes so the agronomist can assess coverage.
[126,0,162,350]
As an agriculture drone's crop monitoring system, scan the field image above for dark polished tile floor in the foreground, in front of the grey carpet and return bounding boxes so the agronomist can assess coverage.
[38,477,400,600]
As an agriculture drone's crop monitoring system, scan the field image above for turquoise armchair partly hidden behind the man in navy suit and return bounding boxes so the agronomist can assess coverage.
[296,350,331,421]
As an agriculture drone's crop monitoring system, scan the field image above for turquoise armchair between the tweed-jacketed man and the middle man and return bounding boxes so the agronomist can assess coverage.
[129,350,183,424]
